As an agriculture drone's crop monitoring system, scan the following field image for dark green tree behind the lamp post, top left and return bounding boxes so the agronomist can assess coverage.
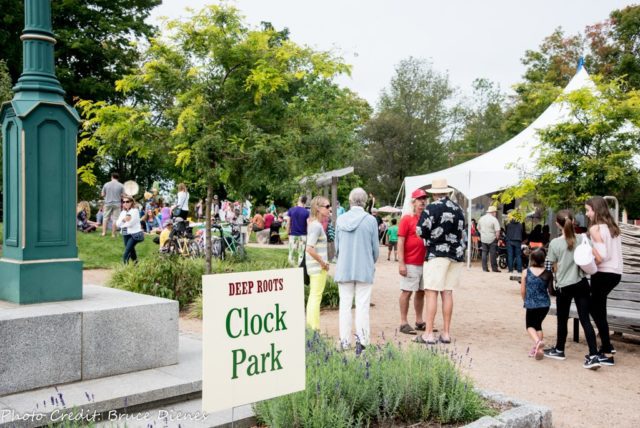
[0,0,161,105]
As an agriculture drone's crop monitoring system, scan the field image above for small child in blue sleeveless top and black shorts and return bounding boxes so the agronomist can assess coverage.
[520,248,553,360]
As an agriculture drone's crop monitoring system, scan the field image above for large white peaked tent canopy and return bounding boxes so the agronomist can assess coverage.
[403,67,595,213]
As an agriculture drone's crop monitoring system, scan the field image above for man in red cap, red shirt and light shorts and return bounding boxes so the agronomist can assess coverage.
[398,189,427,334]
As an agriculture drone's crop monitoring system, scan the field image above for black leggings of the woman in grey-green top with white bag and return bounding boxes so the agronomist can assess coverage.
[556,278,598,355]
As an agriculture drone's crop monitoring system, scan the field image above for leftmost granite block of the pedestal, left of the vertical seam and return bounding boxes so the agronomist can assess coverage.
[0,312,82,396]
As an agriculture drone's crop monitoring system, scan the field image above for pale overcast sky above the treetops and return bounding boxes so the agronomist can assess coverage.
[151,0,638,106]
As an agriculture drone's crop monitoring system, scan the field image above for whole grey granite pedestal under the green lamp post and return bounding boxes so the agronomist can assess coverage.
[0,286,178,396]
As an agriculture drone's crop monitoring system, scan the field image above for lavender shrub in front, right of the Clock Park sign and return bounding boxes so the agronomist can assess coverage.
[254,333,496,427]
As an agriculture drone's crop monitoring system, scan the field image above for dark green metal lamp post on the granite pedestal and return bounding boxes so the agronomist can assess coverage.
[0,0,82,303]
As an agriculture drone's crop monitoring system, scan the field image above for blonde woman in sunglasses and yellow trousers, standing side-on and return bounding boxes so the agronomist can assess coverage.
[305,196,331,330]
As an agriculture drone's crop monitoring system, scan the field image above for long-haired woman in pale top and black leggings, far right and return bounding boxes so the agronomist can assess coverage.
[585,196,622,366]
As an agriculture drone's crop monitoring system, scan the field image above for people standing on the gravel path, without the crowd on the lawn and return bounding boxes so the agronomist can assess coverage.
[302,179,622,370]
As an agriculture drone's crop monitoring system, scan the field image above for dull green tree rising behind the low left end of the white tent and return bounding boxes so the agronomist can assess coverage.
[358,58,453,202]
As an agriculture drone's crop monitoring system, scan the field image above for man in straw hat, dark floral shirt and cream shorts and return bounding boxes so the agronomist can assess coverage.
[415,178,464,345]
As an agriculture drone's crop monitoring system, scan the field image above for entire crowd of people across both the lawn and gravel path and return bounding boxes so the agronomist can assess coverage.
[77,173,622,369]
